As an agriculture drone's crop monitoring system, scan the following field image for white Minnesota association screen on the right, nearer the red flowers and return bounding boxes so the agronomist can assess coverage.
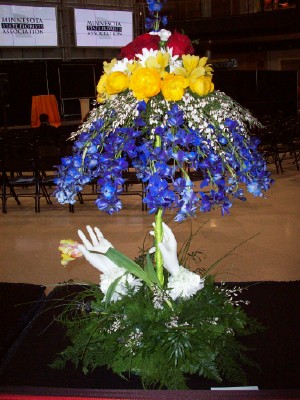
[74,8,133,47]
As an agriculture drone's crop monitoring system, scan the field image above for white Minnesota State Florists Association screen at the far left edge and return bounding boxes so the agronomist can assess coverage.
[0,5,57,47]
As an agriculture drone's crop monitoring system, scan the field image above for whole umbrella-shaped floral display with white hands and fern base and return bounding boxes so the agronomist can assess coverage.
[55,0,272,389]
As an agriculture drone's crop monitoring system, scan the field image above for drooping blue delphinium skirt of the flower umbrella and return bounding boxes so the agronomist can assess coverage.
[55,90,272,221]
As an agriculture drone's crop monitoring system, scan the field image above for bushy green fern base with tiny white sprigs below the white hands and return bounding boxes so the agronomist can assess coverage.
[52,277,262,389]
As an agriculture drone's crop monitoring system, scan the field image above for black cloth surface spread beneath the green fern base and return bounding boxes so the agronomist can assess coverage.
[0,281,300,390]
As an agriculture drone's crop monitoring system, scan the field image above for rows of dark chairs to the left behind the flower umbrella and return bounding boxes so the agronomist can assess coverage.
[0,138,146,213]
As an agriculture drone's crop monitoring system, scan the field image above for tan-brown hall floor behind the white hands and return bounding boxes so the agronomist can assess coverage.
[0,164,300,290]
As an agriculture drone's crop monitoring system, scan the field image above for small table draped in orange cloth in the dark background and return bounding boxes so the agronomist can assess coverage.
[31,94,61,128]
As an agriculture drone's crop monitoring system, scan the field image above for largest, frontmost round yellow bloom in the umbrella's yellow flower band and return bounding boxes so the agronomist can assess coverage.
[129,68,161,101]
